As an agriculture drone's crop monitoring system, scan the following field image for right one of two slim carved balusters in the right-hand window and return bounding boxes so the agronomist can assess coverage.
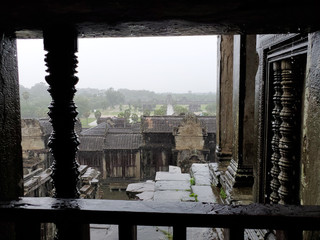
[279,59,297,204]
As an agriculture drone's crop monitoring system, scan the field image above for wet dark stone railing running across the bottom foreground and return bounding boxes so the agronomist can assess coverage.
[0,198,320,240]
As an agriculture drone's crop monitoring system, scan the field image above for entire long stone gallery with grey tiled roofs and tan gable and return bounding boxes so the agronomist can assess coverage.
[78,114,215,185]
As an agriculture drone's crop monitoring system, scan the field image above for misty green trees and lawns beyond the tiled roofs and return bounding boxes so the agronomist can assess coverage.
[20,83,216,123]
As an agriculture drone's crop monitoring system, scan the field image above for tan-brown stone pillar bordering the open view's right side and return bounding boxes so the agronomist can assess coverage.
[216,35,233,173]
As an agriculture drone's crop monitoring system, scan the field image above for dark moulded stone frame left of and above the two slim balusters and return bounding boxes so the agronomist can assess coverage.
[253,34,308,203]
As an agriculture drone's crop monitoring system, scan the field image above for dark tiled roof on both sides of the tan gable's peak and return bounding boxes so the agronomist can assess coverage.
[141,116,216,133]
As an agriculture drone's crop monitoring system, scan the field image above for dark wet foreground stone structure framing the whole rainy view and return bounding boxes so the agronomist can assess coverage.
[0,0,320,239]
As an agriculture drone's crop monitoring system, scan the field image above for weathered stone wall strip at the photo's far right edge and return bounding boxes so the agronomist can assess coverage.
[300,32,320,205]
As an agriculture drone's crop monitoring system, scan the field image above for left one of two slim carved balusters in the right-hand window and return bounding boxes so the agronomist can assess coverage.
[270,62,282,203]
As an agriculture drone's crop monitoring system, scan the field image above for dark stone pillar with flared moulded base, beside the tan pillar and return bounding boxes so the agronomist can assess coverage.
[221,35,258,203]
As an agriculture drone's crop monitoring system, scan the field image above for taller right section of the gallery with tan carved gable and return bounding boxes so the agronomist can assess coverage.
[141,114,215,175]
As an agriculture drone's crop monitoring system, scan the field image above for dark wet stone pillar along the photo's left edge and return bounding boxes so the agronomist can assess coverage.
[0,32,23,239]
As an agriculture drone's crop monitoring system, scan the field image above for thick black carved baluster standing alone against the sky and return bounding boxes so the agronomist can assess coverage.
[44,26,79,198]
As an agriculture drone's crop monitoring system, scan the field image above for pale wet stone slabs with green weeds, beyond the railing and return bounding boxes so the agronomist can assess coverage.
[91,164,219,240]
